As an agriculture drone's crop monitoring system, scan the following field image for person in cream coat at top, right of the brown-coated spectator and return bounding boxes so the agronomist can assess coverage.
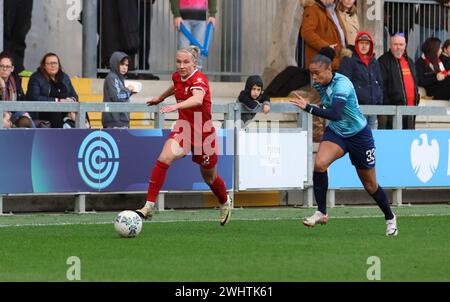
[337,0,359,50]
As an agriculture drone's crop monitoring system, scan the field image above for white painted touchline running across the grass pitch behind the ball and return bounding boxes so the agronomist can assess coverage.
[0,213,450,228]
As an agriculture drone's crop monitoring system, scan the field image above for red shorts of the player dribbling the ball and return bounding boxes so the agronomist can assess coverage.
[169,131,218,170]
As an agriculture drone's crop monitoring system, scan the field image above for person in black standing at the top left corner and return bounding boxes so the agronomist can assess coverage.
[3,0,33,73]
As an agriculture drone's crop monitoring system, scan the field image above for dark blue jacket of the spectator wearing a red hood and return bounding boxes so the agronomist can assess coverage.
[339,53,383,105]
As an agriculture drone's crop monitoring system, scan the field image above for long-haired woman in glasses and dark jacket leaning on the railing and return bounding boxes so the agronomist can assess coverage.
[27,53,78,128]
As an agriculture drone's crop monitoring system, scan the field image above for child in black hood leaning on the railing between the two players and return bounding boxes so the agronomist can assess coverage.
[238,75,270,128]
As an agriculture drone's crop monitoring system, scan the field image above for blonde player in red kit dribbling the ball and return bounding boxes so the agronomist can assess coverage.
[136,46,231,226]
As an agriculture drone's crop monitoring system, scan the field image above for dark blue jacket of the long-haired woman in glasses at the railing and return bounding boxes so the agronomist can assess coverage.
[26,70,78,102]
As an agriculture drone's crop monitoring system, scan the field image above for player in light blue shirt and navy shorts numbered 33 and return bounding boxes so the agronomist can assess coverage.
[290,47,398,236]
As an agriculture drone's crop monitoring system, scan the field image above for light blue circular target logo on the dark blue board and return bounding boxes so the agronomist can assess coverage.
[78,131,119,190]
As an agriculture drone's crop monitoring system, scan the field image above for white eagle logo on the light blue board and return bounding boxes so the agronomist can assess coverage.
[411,133,439,183]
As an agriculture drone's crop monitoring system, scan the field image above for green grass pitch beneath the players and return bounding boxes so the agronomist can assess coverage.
[0,205,450,282]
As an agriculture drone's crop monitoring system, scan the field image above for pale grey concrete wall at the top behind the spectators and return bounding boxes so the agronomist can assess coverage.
[24,0,277,79]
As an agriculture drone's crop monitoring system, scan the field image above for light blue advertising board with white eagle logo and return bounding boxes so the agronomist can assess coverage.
[328,130,450,189]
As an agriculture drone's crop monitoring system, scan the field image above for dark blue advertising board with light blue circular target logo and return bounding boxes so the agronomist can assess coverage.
[0,129,234,194]
